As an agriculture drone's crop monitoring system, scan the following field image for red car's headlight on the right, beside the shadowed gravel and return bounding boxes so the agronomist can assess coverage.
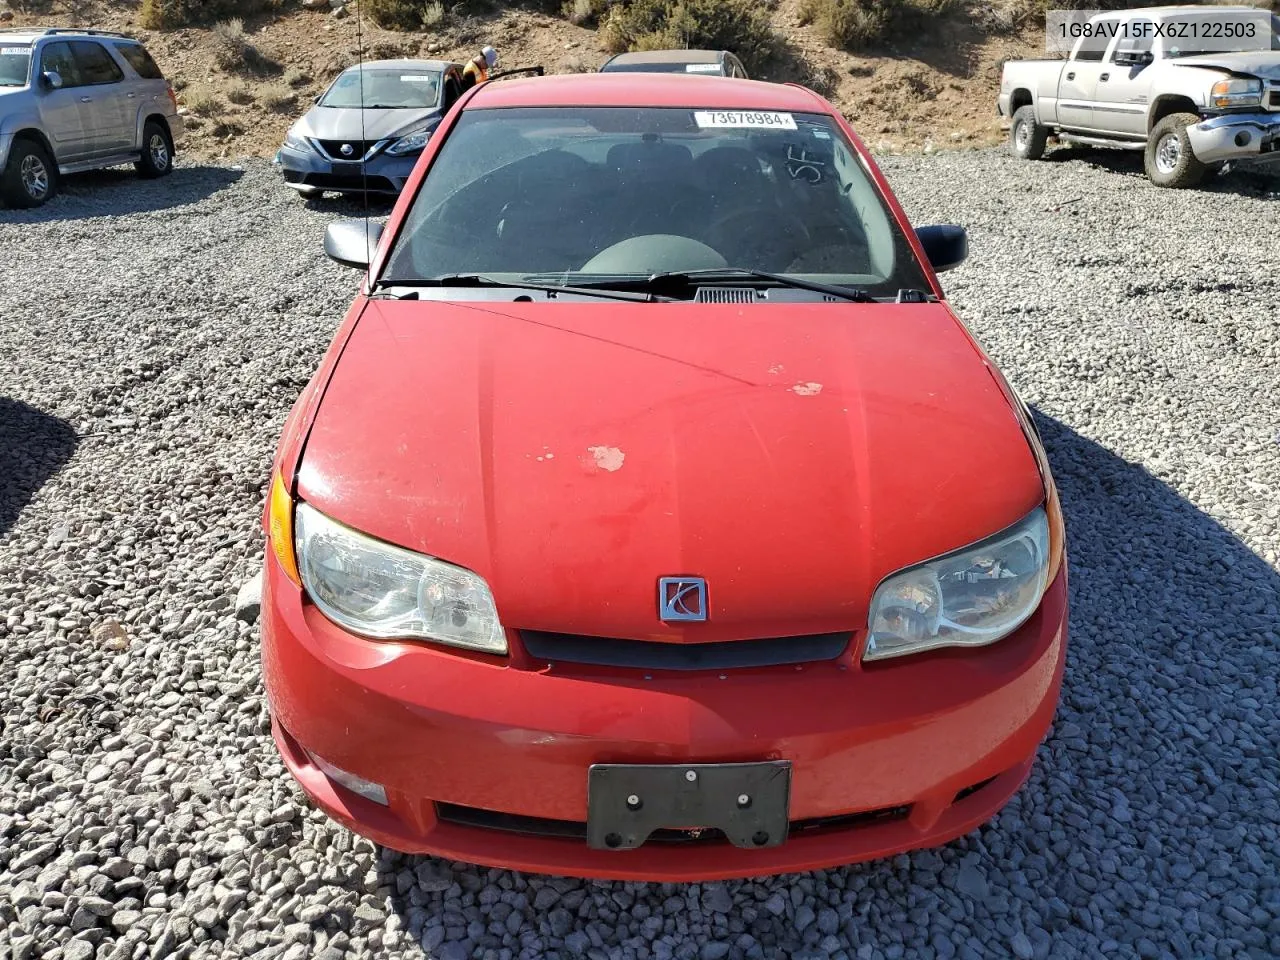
[863,507,1050,660]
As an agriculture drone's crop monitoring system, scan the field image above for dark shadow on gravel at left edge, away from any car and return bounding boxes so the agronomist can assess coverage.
[0,397,79,536]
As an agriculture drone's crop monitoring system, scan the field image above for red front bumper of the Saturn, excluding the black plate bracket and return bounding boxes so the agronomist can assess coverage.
[262,556,1066,881]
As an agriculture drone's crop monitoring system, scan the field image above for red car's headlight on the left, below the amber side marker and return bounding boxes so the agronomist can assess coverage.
[294,503,507,654]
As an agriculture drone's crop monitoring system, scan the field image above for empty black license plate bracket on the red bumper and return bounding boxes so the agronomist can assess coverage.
[586,760,791,850]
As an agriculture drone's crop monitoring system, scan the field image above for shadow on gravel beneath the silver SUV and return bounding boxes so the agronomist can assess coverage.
[0,166,243,223]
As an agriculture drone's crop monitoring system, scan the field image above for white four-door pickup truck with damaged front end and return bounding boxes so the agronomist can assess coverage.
[997,6,1280,187]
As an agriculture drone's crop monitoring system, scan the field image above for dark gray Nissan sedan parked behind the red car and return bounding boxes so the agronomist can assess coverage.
[276,60,462,197]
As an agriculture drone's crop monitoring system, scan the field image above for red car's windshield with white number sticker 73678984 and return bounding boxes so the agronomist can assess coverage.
[380,108,928,297]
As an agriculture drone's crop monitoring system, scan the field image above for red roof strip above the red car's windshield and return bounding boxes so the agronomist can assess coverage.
[467,73,831,113]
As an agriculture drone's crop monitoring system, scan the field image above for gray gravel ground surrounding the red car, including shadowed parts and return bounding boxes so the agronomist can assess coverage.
[0,152,1280,960]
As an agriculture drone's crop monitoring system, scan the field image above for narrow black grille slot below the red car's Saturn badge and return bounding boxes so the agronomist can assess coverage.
[520,630,852,671]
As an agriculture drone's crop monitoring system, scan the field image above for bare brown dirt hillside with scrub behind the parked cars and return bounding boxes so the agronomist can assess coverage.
[0,0,1042,159]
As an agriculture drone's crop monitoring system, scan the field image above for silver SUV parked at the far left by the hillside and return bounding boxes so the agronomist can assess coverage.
[0,27,183,207]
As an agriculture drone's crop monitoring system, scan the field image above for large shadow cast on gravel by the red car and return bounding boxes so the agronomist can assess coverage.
[366,411,1280,960]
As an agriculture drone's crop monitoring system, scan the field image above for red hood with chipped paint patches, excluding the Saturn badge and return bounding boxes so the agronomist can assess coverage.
[300,300,1043,641]
